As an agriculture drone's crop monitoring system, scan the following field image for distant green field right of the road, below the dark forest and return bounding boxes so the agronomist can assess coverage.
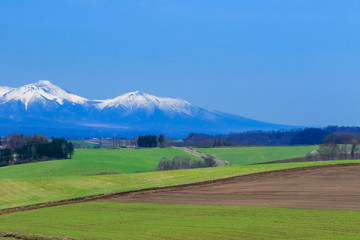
[196,146,318,165]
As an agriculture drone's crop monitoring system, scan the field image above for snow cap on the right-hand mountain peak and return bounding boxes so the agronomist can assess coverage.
[97,91,194,114]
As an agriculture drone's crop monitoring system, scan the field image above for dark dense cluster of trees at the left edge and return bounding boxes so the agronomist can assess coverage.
[0,133,74,166]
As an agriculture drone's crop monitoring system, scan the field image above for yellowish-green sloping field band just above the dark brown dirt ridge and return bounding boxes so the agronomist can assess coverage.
[0,160,360,209]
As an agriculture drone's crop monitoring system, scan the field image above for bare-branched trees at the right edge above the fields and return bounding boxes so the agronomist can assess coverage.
[308,133,360,161]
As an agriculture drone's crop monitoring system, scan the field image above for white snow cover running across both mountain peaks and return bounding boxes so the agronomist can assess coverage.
[0,81,197,115]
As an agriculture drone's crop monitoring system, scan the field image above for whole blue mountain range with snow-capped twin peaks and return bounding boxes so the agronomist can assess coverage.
[0,81,291,137]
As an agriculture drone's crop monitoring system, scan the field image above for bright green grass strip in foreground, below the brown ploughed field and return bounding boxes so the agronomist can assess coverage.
[0,202,360,240]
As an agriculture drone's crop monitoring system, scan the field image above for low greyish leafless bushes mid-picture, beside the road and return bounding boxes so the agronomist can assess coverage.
[157,156,217,171]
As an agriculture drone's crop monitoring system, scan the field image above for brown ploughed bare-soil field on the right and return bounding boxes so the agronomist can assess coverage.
[106,165,360,210]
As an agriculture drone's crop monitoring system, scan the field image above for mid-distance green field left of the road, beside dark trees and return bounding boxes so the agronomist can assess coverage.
[0,148,200,180]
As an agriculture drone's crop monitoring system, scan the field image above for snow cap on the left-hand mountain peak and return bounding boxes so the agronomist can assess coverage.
[0,81,88,109]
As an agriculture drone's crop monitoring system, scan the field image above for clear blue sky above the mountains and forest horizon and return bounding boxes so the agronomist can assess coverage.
[0,0,360,126]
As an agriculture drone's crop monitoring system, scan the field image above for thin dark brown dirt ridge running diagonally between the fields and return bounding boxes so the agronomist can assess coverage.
[0,163,360,215]
